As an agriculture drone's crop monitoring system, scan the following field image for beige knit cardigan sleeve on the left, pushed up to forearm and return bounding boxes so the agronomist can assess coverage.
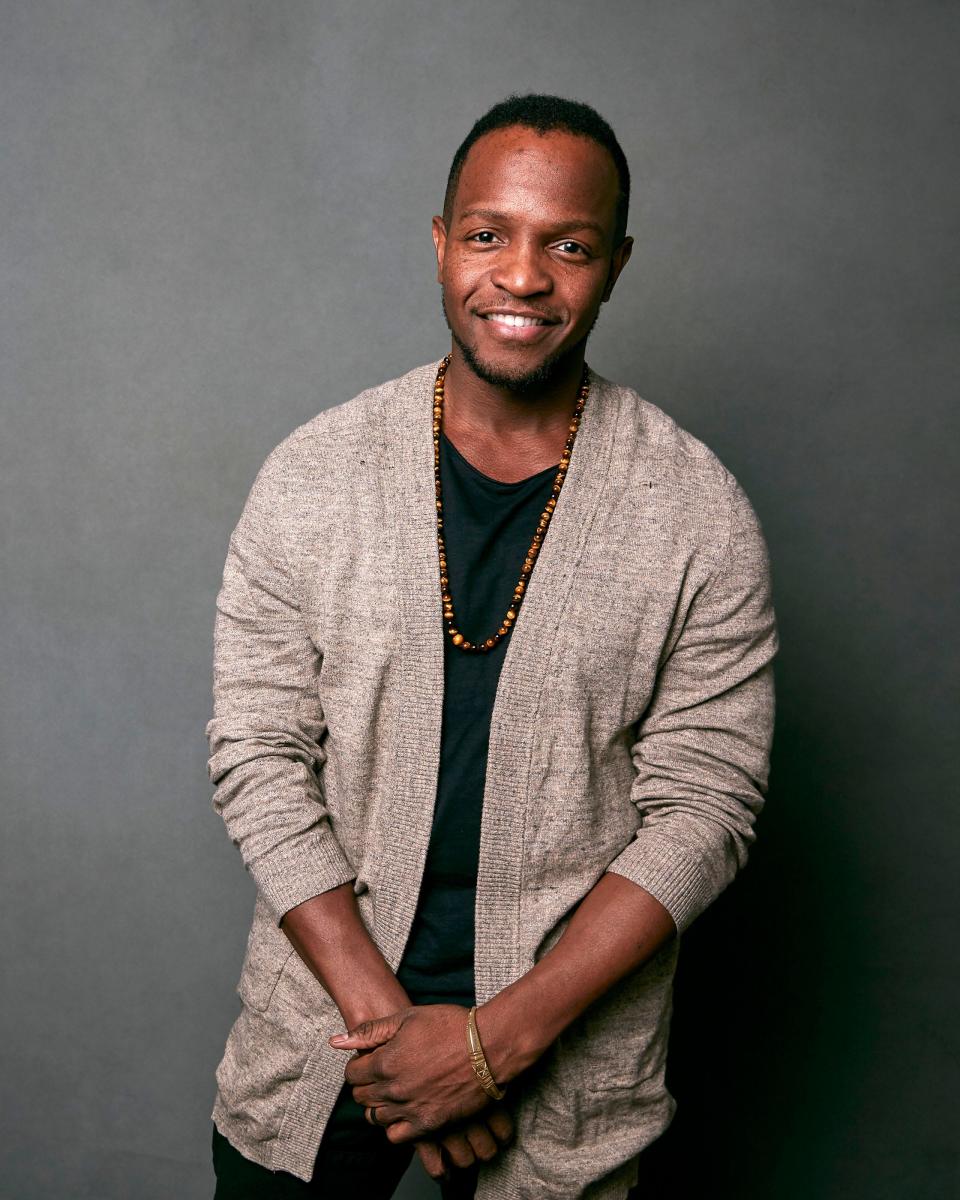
[206,444,355,922]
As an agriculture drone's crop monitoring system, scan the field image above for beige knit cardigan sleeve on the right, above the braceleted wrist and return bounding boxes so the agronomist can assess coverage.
[607,476,778,932]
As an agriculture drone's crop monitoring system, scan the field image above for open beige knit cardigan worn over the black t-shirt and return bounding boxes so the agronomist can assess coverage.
[206,362,778,1200]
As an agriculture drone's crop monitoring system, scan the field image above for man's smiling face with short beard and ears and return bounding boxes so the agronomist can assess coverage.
[433,126,631,391]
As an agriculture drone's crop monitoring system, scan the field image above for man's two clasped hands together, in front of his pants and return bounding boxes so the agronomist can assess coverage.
[330,1004,512,1176]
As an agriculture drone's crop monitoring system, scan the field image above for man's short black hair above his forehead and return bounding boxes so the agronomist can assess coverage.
[443,92,630,246]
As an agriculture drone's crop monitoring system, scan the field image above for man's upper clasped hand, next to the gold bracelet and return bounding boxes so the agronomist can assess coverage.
[330,1004,490,1152]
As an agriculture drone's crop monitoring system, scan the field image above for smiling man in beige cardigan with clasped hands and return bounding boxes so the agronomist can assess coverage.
[208,96,776,1200]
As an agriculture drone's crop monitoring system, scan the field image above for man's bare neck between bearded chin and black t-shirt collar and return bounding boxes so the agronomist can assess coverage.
[444,343,583,442]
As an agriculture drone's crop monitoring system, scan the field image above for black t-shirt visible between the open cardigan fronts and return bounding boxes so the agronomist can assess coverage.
[397,433,557,1006]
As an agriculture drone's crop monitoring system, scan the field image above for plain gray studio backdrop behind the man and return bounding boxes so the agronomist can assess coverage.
[0,0,960,1200]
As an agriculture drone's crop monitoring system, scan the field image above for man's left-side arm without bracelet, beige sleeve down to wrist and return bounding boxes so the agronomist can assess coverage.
[206,450,409,1020]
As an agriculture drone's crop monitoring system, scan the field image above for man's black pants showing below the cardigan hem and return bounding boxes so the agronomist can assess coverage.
[214,1084,476,1200]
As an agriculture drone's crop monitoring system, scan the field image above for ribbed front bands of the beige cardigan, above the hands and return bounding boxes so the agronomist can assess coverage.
[376,361,619,1003]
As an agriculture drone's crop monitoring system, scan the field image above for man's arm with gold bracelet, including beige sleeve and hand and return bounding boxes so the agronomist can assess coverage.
[333,486,778,1141]
